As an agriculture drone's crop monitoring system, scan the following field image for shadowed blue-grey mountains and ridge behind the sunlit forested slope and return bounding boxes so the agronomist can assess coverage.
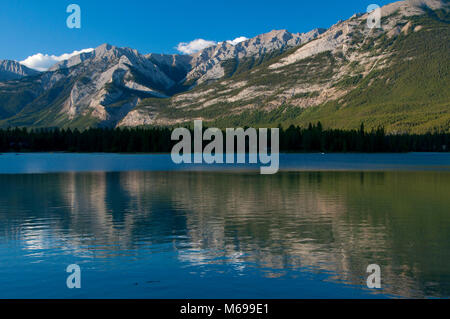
[0,30,321,128]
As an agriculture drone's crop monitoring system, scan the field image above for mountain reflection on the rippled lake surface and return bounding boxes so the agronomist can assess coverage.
[0,172,450,297]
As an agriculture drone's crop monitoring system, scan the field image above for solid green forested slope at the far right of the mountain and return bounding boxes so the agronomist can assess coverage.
[288,13,450,133]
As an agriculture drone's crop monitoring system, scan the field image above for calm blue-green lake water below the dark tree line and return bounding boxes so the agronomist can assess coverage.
[0,154,450,298]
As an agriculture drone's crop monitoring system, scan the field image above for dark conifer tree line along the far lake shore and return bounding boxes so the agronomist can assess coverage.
[0,122,450,153]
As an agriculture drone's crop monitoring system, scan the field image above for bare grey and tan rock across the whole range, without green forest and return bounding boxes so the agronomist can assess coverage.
[0,0,444,127]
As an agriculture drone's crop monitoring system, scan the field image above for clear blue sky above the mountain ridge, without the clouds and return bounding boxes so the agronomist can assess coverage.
[0,0,393,61]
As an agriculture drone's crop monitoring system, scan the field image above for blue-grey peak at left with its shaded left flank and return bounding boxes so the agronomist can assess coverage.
[0,44,179,126]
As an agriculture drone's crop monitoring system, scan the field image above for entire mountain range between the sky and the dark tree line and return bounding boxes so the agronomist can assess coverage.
[0,0,450,133]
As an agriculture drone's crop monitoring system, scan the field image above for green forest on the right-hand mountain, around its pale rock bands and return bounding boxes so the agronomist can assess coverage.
[170,11,450,134]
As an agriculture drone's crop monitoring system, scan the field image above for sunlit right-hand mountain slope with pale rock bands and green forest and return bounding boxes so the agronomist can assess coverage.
[120,0,450,133]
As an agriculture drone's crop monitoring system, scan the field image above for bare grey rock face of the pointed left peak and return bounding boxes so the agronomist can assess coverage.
[33,44,176,126]
